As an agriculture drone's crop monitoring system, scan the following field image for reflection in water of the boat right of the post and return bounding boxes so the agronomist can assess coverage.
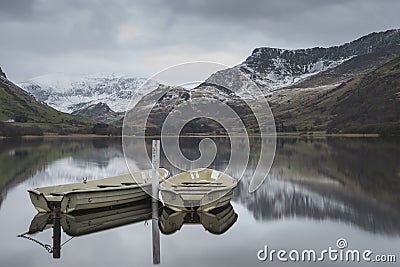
[159,203,238,235]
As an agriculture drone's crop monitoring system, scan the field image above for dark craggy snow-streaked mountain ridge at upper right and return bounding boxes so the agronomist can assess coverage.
[235,29,400,92]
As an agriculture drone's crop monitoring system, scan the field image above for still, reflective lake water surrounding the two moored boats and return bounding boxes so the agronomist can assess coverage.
[0,138,400,267]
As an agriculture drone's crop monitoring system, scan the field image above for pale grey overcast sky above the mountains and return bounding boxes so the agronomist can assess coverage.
[0,0,400,82]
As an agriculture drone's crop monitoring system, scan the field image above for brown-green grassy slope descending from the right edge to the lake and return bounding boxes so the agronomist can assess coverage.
[271,58,400,136]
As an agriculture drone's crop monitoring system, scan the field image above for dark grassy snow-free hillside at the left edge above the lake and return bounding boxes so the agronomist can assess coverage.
[0,71,94,136]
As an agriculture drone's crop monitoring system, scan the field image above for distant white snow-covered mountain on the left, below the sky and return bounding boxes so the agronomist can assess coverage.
[19,73,157,113]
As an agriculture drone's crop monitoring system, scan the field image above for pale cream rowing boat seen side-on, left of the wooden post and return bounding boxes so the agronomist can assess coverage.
[28,168,169,213]
